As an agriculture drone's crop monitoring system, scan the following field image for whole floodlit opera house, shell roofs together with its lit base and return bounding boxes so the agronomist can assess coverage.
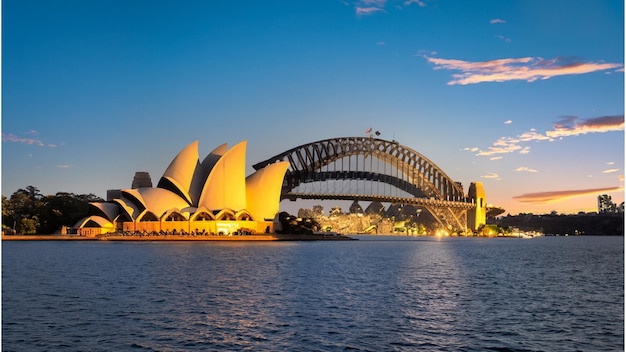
[75,141,289,236]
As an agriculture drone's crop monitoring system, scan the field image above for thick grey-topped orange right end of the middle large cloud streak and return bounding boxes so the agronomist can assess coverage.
[546,115,624,138]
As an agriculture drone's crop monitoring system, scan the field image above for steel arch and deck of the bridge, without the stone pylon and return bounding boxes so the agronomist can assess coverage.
[253,137,475,229]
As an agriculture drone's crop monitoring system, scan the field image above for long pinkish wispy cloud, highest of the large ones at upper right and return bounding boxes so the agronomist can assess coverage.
[423,55,623,85]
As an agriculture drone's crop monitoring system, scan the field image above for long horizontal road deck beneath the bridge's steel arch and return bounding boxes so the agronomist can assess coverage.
[281,192,476,209]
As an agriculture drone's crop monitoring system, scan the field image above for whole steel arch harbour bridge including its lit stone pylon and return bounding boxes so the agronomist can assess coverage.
[253,136,486,230]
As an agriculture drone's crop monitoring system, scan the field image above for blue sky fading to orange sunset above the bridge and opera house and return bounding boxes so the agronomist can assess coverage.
[1,0,624,215]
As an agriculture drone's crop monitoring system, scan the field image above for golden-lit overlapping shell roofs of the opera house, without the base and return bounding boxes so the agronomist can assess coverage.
[83,140,289,226]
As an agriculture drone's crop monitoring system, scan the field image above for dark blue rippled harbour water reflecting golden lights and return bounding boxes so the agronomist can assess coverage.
[2,236,624,351]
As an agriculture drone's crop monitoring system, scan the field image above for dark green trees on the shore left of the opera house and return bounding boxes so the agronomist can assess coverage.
[2,186,104,234]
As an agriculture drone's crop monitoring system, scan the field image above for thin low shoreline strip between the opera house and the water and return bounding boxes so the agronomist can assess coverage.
[2,234,357,242]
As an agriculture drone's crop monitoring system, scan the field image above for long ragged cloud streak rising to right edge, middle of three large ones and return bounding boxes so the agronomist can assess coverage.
[464,115,624,156]
